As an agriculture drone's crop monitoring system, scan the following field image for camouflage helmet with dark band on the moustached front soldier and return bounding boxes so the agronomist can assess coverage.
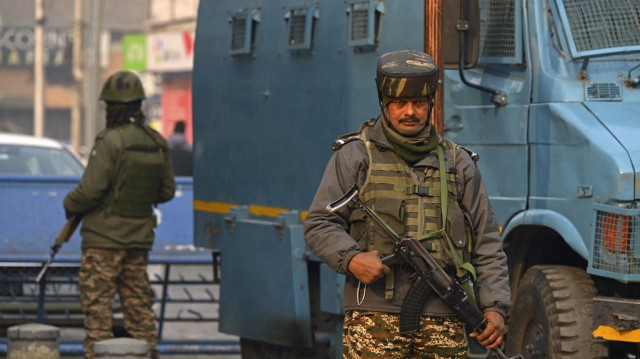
[376,50,438,105]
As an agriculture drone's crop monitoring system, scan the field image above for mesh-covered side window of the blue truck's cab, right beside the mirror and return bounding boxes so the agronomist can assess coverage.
[480,0,516,58]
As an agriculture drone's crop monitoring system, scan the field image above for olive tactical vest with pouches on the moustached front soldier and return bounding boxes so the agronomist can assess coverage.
[349,125,475,298]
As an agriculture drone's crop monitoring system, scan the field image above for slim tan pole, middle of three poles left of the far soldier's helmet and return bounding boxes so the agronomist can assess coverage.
[70,0,84,153]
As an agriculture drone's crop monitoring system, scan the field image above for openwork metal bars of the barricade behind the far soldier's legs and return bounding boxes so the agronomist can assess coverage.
[0,252,240,355]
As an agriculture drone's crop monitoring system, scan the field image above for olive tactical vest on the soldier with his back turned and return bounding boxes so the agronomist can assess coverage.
[107,124,166,217]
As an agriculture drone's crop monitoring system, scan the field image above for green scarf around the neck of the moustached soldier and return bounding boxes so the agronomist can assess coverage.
[382,119,438,166]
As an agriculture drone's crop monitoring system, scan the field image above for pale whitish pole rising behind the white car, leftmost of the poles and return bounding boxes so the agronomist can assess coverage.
[33,0,45,137]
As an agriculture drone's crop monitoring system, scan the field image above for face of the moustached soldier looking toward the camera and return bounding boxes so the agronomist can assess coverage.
[387,97,431,136]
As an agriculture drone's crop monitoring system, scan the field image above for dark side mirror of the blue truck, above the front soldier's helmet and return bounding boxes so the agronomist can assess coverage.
[442,0,480,69]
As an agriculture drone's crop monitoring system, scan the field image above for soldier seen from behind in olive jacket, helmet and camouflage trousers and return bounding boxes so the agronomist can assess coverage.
[64,71,175,359]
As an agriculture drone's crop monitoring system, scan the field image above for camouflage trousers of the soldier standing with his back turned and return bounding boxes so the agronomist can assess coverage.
[79,248,159,359]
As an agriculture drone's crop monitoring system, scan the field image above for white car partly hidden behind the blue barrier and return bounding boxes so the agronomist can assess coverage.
[0,132,85,176]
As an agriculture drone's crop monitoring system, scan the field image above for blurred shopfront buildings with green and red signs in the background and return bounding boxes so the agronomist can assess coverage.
[0,0,199,157]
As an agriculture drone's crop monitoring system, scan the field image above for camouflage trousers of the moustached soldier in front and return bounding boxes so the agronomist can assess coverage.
[342,311,468,359]
